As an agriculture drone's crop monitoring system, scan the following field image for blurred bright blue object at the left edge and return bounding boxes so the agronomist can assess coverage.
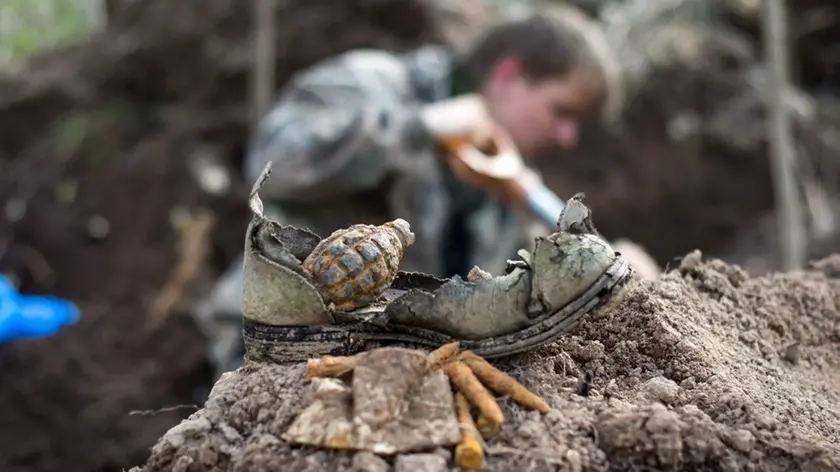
[0,275,79,344]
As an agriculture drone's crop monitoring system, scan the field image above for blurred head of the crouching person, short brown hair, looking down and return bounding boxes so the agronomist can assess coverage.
[462,8,617,155]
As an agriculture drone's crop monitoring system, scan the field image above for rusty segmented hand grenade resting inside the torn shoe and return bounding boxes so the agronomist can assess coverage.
[303,219,414,311]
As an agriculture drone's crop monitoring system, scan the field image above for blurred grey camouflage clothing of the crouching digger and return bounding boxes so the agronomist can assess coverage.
[245,46,526,276]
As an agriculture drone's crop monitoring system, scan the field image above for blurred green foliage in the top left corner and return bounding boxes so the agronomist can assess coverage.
[0,0,103,63]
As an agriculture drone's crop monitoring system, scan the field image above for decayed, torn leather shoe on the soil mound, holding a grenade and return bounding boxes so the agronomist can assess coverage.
[242,167,632,362]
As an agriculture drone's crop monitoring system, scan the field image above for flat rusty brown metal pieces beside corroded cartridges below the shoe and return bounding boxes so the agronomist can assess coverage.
[282,348,460,454]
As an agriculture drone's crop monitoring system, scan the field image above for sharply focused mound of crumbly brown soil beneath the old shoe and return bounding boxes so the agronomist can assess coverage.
[134,252,840,472]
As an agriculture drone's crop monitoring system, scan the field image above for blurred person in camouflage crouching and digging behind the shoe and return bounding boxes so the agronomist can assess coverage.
[202,9,656,380]
